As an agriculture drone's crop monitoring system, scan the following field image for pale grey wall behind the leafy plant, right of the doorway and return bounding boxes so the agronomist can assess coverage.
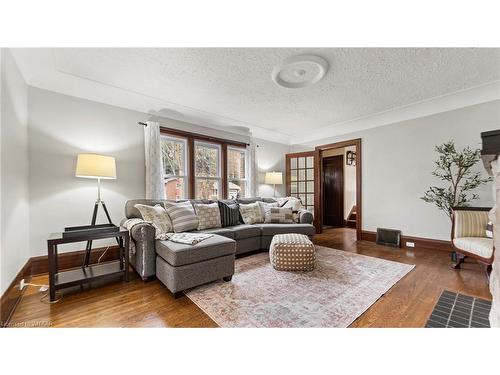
[293,100,500,240]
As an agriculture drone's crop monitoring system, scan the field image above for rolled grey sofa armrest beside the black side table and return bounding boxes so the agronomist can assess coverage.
[119,223,156,280]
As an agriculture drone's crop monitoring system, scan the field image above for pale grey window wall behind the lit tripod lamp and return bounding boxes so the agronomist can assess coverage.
[29,87,288,256]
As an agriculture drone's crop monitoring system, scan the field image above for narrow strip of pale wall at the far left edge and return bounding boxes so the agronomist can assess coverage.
[0,49,29,294]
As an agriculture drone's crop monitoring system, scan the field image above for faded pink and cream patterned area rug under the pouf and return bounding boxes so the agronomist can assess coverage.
[186,246,415,328]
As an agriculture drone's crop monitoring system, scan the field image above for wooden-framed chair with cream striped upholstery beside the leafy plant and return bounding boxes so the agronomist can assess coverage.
[451,207,495,275]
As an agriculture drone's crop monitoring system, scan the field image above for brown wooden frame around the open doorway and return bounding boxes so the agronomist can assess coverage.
[314,138,362,241]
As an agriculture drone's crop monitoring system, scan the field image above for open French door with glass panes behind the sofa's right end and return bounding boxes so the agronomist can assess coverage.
[286,151,315,213]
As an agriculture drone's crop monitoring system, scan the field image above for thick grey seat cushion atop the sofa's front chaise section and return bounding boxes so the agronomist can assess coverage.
[156,234,236,267]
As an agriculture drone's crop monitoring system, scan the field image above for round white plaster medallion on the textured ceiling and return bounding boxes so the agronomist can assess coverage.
[272,55,328,89]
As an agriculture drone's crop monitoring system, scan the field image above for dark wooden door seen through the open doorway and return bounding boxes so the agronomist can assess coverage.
[323,155,344,227]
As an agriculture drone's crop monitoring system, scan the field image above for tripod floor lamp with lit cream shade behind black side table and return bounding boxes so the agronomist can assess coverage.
[75,154,120,267]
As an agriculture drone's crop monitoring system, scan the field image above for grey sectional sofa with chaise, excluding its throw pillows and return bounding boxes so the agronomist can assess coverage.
[124,198,315,297]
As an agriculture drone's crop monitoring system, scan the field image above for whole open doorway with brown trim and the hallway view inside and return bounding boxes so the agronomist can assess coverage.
[314,139,361,240]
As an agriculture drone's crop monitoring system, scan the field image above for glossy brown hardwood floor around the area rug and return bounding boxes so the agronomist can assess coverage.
[11,228,491,327]
